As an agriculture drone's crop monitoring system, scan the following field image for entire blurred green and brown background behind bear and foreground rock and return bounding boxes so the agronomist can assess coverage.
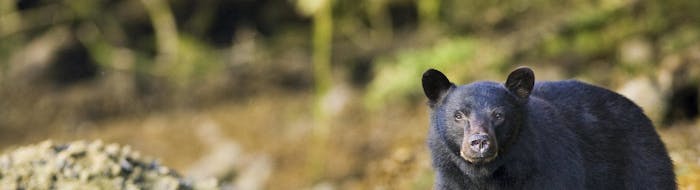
[0,0,700,189]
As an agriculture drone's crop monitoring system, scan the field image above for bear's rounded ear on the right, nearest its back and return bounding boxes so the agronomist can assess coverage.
[505,67,535,98]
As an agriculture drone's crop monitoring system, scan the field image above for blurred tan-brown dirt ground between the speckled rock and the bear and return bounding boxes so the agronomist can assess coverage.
[2,94,700,189]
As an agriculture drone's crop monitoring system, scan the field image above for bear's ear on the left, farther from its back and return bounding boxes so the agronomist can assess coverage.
[422,69,454,108]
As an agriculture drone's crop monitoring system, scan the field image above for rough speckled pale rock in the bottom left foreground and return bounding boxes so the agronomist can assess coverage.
[0,141,219,190]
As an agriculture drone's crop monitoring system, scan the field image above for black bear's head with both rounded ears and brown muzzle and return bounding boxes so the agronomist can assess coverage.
[422,67,535,165]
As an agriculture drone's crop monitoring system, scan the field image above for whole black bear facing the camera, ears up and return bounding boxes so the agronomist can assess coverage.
[422,67,677,189]
